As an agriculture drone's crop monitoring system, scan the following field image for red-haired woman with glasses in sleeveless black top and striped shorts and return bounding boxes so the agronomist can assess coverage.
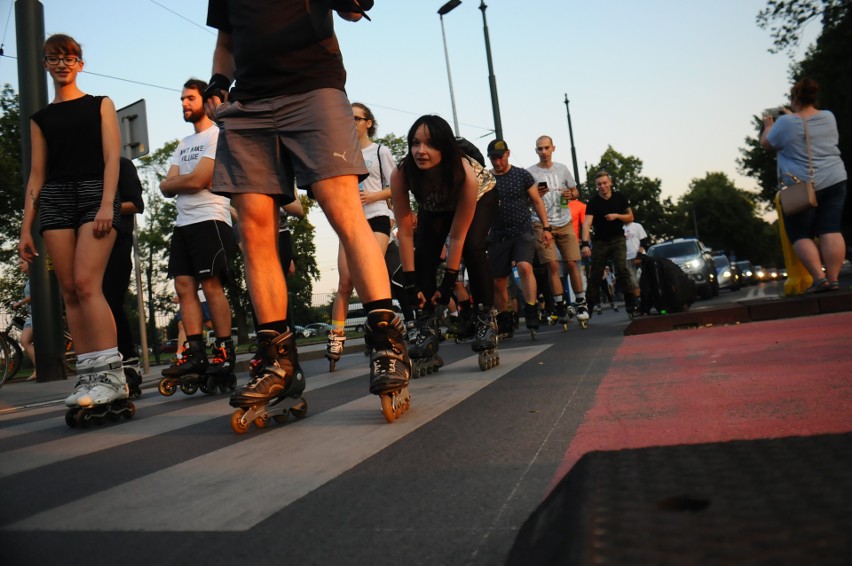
[18,34,134,426]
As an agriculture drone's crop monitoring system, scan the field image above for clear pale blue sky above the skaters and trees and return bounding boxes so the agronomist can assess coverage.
[0,0,818,298]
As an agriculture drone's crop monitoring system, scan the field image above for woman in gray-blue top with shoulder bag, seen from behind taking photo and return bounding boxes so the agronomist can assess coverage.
[760,78,846,292]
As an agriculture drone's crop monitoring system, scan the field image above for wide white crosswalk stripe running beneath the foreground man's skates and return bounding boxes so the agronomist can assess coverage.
[4,344,550,531]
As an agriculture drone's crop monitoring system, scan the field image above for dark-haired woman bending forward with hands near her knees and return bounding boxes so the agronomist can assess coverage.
[391,115,499,371]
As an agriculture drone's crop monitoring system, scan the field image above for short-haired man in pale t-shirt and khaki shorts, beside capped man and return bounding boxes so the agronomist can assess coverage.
[527,136,589,323]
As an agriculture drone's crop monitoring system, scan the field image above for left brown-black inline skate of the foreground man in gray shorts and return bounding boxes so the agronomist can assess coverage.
[229,330,308,434]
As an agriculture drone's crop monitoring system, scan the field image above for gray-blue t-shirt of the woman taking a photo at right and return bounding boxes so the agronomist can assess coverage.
[766,110,846,190]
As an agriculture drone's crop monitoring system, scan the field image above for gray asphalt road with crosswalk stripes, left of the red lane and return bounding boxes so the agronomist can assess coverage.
[0,283,800,565]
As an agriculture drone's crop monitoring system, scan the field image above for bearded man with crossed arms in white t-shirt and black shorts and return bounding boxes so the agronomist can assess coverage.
[160,79,235,383]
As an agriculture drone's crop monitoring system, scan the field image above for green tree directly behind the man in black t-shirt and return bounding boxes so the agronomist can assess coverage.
[586,146,680,240]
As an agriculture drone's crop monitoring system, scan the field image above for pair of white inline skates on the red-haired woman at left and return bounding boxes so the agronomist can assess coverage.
[65,354,136,428]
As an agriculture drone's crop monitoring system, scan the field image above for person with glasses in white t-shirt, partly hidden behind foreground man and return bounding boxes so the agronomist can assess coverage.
[325,102,396,371]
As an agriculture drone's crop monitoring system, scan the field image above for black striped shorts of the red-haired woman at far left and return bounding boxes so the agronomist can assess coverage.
[38,179,121,233]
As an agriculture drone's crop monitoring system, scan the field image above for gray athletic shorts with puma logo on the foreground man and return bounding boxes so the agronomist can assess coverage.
[213,88,368,203]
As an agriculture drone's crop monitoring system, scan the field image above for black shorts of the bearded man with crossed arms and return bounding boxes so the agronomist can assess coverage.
[169,220,234,281]
